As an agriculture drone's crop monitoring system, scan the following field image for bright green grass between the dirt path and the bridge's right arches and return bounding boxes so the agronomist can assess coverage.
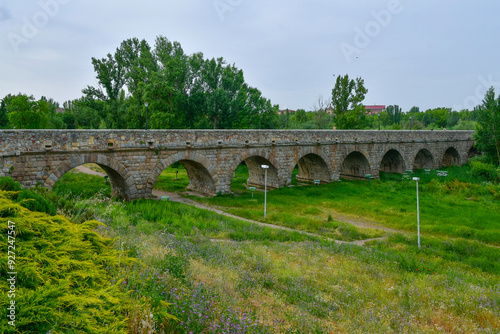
[192,164,500,245]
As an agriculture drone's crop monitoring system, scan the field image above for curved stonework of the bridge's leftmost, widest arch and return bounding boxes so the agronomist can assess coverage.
[45,154,137,201]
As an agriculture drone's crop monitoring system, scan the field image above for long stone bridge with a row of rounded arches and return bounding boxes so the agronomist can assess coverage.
[0,130,477,200]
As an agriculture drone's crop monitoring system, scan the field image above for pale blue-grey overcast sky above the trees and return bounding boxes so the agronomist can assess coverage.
[0,0,500,111]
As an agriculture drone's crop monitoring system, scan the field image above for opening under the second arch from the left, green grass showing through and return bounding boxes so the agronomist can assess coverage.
[153,159,216,196]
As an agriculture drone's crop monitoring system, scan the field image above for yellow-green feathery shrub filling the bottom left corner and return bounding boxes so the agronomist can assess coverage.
[0,192,129,333]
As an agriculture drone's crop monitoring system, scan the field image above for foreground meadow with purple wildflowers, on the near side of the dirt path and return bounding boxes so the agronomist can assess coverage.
[60,192,500,333]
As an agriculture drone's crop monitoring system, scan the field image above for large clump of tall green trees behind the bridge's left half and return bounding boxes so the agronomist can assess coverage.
[0,36,278,129]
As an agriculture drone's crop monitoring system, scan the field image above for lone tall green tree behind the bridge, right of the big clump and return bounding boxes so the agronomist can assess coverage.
[332,74,368,129]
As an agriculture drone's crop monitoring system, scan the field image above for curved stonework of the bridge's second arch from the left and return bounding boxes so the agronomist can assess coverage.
[148,151,217,195]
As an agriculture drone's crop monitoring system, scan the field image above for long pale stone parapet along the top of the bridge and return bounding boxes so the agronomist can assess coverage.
[0,130,473,156]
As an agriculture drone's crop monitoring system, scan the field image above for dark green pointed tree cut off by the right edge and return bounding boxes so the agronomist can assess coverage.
[475,87,500,164]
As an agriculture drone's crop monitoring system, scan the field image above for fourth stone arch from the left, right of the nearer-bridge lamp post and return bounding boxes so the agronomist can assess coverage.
[289,149,333,183]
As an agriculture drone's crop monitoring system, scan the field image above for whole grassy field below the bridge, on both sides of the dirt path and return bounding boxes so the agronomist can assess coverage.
[36,163,500,333]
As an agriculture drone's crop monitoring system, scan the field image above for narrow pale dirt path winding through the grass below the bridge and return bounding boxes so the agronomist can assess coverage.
[153,189,388,246]
